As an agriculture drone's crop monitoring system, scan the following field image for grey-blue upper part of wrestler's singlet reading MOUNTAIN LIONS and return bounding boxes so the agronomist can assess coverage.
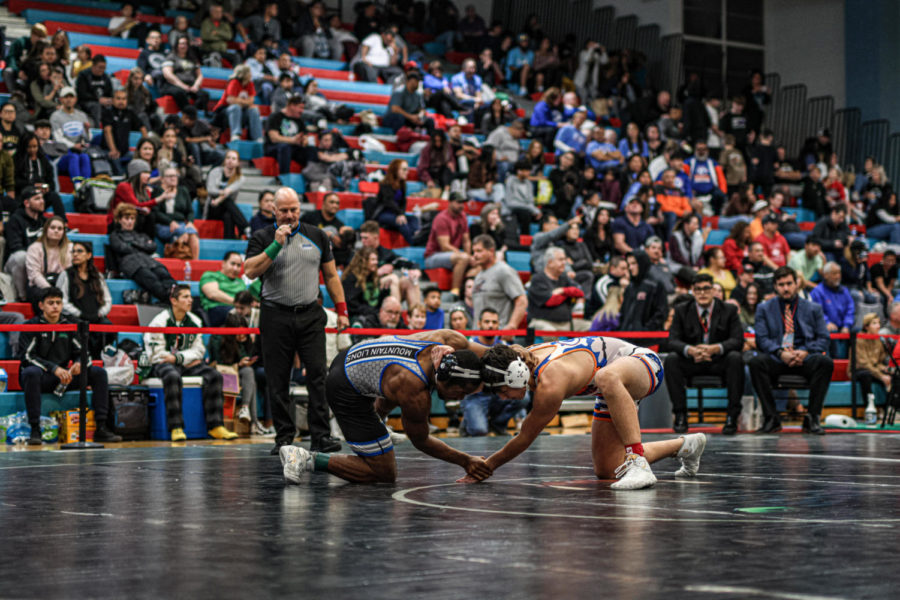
[344,336,437,397]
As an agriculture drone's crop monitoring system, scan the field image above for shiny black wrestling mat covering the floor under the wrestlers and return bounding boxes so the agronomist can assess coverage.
[0,434,900,600]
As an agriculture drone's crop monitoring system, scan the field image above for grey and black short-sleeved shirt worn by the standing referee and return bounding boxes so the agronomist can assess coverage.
[247,223,334,306]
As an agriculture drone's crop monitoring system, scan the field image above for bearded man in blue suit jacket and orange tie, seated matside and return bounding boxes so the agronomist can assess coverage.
[749,267,834,435]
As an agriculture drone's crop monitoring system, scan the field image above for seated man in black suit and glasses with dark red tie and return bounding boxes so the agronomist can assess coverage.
[664,273,744,435]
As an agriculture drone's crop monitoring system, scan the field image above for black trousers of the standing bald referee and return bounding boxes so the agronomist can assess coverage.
[259,303,331,446]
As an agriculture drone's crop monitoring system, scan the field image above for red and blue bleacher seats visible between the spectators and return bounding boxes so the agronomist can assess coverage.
[0,0,880,426]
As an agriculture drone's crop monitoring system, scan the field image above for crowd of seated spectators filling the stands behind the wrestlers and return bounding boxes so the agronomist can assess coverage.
[0,0,900,439]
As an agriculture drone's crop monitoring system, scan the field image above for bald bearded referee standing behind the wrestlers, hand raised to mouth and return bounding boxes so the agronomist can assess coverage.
[244,187,350,455]
